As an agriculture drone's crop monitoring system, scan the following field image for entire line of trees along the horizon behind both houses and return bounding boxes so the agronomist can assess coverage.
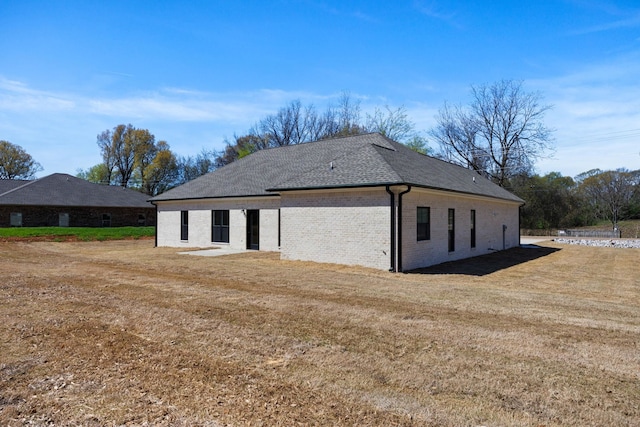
[0,80,640,229]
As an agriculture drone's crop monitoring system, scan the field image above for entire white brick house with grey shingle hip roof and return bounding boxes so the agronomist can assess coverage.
[151,134,524,271]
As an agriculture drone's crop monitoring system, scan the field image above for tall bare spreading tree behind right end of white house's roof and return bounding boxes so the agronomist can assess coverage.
[430,80,552,186]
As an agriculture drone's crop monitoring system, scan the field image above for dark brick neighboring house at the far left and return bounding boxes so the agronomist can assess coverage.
[0,173,156,227]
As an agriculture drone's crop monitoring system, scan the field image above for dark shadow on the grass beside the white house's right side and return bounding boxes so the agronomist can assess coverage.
[405,245,560,276]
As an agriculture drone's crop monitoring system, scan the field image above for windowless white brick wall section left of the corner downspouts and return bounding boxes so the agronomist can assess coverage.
[281,188,391,270]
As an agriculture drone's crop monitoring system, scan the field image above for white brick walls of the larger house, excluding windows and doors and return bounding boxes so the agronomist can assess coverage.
[158,187,519,270]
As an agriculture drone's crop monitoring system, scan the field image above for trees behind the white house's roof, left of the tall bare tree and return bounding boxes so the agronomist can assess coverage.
[78,93,427,196]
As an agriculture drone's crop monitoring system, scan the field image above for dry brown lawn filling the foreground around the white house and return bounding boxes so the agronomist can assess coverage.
[0,240,640,426]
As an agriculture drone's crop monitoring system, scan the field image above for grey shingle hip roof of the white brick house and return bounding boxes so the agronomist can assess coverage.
[151,133,523,203]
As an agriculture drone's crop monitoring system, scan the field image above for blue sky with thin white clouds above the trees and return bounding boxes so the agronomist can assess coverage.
[0,0,640,176]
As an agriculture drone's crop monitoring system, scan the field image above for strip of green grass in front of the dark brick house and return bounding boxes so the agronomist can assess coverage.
[0,227,155,242]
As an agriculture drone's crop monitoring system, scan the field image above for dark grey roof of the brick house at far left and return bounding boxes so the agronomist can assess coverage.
[0,173,153,208]
